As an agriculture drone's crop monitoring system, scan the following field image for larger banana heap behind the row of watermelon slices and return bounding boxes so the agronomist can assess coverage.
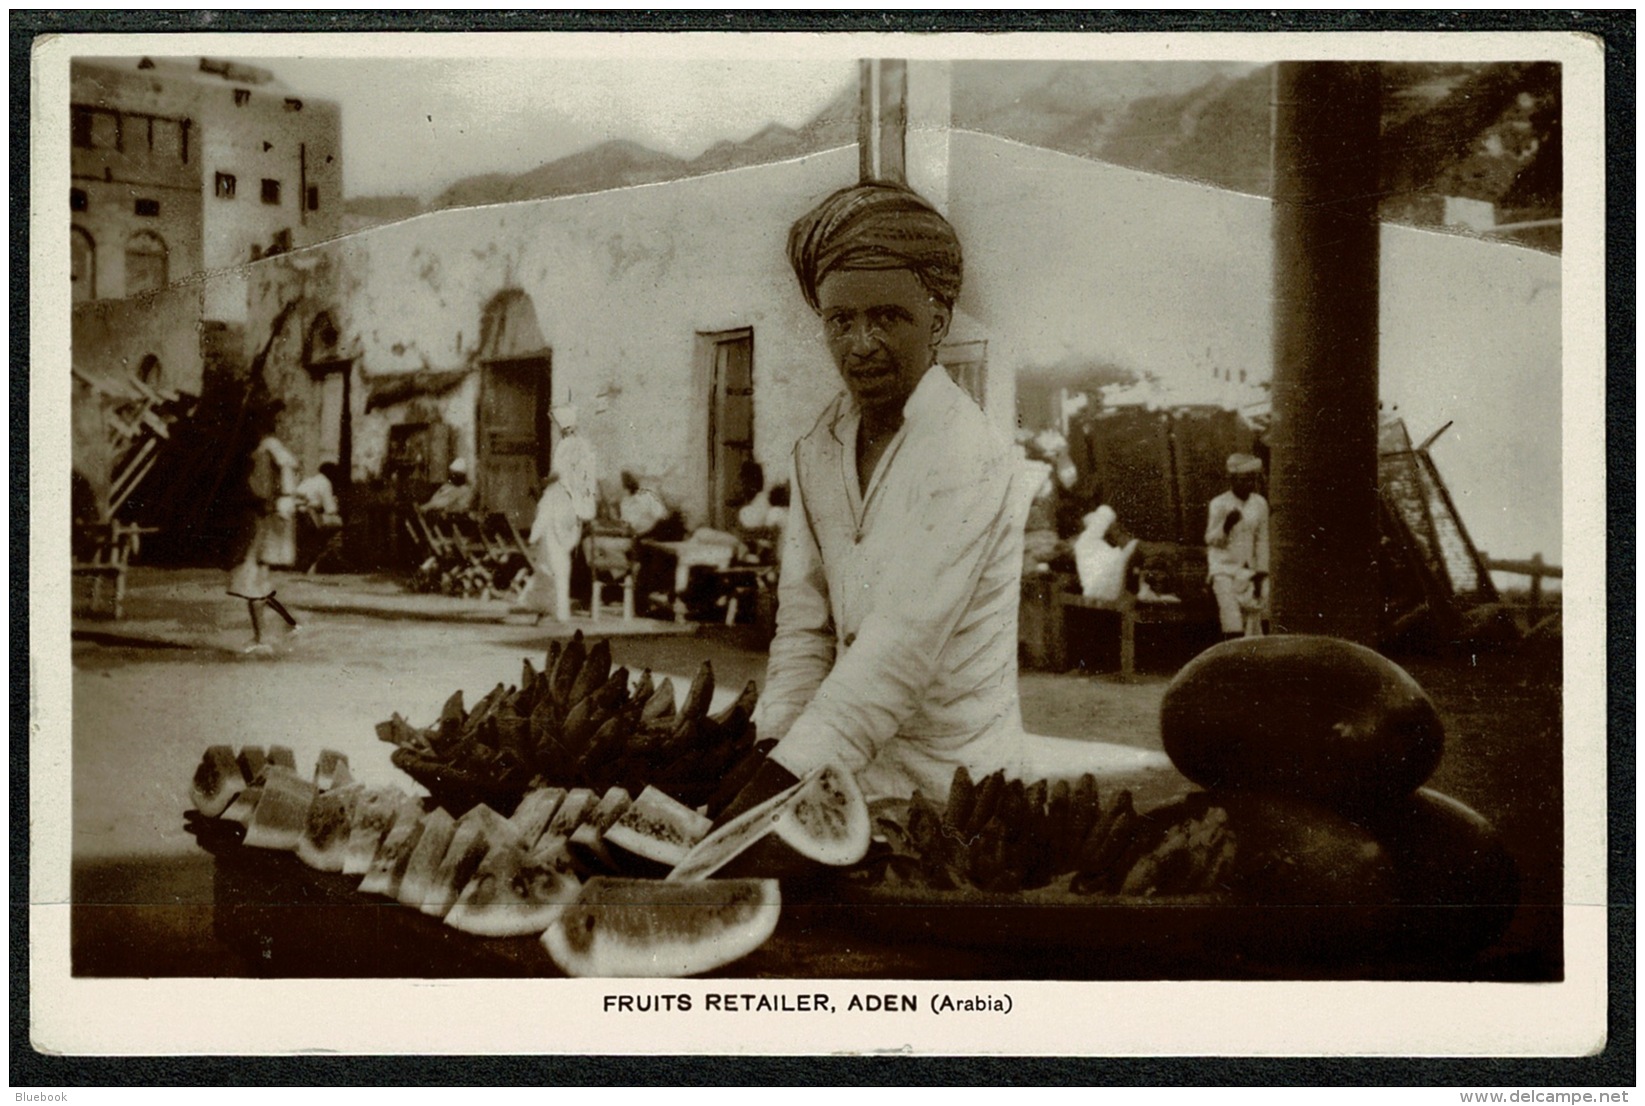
[377,630,758,806]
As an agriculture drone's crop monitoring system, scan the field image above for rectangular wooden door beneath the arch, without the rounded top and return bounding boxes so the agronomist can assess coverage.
[475,357,549,530]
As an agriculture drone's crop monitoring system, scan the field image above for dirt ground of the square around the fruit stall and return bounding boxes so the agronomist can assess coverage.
[63,569,1563,979]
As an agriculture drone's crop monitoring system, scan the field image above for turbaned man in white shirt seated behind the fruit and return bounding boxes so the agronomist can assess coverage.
[730,183,1026,813]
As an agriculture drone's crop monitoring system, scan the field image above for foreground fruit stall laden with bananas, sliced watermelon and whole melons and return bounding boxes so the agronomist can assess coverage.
[184,634,1518,979]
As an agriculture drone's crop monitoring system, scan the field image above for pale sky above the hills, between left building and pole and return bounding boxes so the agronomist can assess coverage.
[243,56,855,199]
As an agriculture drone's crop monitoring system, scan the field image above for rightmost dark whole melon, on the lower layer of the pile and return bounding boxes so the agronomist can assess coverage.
[1365,787,1520,963]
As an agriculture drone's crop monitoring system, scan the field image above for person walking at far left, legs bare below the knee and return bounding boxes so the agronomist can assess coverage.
[229,400,298,652]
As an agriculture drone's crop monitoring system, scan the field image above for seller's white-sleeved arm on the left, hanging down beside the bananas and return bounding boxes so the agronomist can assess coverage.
[755,467,834,739]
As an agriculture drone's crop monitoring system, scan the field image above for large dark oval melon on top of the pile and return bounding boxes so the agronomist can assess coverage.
[1160,635,1444,811]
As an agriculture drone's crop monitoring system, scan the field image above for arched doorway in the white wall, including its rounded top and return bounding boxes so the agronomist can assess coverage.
[475,288,553,528]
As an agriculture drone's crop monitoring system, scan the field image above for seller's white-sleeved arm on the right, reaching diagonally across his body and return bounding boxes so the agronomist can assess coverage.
[772,447,1017,775]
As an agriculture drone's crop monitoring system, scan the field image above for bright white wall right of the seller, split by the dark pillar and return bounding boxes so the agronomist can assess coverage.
[949,133,1561,560]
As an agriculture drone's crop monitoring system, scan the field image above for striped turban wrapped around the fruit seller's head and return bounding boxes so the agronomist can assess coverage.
[788,181,964,311]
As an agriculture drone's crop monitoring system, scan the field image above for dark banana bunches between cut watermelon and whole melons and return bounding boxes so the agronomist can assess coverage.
[878,767,1234,895]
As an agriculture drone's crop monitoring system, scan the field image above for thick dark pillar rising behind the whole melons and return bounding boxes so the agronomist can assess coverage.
[1270,63,1382,645]
